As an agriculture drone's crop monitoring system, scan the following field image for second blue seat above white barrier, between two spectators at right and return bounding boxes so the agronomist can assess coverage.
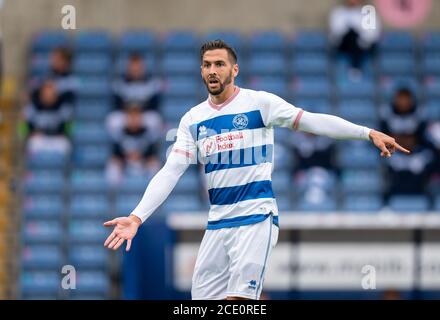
[341,169,383,194]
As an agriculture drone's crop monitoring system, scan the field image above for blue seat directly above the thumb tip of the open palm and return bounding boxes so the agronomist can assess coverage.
[69,195,110,219]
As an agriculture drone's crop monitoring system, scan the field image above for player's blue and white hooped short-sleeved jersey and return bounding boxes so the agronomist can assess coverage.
[173,87,303,229]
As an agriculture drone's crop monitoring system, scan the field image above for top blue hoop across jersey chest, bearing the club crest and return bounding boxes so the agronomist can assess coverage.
[190,110,265,141]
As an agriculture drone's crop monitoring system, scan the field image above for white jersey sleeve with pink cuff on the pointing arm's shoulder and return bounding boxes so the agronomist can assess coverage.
[258,91,304,130]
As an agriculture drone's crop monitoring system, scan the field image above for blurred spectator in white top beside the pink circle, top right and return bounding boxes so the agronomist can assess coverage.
[329,0,381,77]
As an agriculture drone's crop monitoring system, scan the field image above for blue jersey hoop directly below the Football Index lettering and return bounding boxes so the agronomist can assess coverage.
[205,144,273,173]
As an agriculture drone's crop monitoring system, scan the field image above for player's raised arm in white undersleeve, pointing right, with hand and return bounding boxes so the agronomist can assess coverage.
[294,111,410,157]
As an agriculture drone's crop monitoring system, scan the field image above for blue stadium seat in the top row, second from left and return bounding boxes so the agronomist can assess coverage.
[75,30,113,52]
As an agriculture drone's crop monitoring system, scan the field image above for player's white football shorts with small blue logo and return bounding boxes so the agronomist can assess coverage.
[191,215,279,300]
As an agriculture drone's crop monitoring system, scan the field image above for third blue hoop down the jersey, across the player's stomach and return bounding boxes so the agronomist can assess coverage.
[208,180,274,205]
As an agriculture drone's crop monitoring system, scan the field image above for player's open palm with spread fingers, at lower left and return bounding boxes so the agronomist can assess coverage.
[104,216,140,251]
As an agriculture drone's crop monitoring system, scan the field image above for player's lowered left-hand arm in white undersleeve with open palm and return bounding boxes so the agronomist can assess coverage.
[104,151,190,251]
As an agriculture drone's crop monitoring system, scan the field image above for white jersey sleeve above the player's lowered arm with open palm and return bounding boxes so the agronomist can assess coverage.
[172,113,197,161]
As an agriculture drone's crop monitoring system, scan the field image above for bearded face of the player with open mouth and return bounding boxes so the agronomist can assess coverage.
[201,49,238,96]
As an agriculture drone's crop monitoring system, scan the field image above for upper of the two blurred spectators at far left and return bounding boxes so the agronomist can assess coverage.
[31,47,78,103]
